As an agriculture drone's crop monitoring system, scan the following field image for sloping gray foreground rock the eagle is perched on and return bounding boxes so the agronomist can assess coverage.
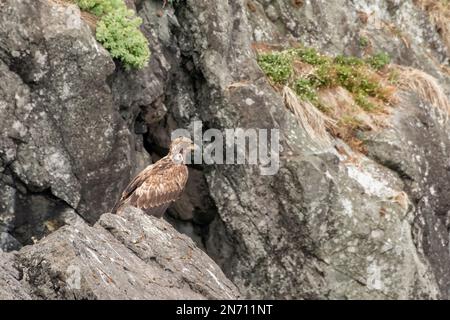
[0,208,239,299]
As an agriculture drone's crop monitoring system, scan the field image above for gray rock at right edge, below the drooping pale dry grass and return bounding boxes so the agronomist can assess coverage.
[367,93,450,292]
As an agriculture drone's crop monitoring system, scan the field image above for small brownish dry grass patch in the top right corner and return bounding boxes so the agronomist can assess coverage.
[414,0,450,54]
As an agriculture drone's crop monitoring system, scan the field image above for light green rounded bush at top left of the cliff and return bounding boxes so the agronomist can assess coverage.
[96,9,150,69]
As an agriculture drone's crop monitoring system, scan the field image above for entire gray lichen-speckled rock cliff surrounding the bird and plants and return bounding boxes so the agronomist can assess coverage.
[0,0,450,299]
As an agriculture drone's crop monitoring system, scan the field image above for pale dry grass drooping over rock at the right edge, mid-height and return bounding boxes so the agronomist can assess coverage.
[393,66,450,117]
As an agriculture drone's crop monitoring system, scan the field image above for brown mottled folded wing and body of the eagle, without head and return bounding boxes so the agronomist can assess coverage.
[113,158,188,217]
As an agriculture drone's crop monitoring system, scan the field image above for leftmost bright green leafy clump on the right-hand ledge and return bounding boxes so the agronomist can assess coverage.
[258,52,293,84]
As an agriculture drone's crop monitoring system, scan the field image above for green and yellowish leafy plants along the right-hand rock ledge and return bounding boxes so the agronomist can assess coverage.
[258,48,390,112]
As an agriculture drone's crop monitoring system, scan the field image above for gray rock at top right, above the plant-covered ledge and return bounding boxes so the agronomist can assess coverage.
[247,0,450,85]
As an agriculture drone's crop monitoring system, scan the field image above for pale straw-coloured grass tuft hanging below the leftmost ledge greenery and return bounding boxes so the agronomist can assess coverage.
[283,86,336,146]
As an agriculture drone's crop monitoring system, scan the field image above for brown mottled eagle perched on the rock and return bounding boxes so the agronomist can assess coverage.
[112,137,195,218]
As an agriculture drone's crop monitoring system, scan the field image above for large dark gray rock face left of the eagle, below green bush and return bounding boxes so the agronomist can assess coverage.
[0,0,153,244]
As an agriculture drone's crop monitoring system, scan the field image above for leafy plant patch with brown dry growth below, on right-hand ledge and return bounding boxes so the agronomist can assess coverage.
[258,47,395,152]
